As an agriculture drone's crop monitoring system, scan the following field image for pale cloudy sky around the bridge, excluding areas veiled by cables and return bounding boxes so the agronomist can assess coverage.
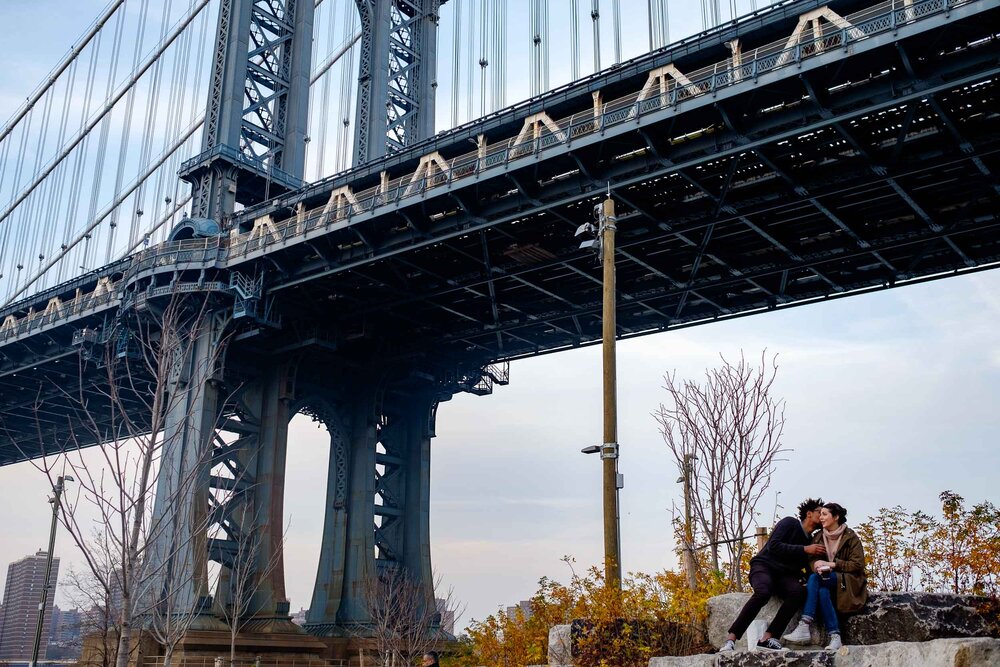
[0,0,1000,636]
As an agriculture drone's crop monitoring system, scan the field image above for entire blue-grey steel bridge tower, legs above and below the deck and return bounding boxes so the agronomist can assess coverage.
[150,0,450,652]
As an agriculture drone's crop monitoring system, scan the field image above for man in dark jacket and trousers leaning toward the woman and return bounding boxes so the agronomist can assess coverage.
[719,498,826,651]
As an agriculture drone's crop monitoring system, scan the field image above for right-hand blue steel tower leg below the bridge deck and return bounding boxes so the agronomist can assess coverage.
[303,382,438,637]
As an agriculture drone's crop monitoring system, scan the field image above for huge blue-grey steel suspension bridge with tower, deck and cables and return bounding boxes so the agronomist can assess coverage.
[0,0,1000,664]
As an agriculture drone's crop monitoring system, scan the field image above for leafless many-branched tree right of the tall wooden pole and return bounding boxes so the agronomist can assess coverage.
[653,351,787,589]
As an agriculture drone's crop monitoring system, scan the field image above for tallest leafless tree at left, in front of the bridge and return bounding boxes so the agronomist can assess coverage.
[16,293,230,667]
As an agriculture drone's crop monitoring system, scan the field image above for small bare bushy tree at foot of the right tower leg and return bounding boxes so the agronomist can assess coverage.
[364,567,464,667]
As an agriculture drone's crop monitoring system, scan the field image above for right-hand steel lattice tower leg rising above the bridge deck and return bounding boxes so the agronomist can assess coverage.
[354,0,443,165]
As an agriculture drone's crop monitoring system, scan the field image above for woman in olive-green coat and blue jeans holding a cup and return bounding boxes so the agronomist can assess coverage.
[783,503,868,650]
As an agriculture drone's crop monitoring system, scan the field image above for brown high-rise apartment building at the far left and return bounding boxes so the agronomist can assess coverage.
[0,551,59,660]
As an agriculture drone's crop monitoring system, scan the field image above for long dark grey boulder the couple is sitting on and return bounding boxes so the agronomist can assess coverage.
[708,593,1000,648]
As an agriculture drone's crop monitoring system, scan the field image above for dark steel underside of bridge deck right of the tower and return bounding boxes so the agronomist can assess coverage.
[271,13,1000,360]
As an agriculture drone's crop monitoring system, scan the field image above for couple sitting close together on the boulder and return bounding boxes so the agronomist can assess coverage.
[719,499,868,651]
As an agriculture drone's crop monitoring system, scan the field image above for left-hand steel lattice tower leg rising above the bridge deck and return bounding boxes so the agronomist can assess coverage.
[180,0,315,224]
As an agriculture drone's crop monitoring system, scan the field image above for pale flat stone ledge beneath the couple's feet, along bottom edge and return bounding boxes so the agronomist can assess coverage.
[649,638,1000,667]
